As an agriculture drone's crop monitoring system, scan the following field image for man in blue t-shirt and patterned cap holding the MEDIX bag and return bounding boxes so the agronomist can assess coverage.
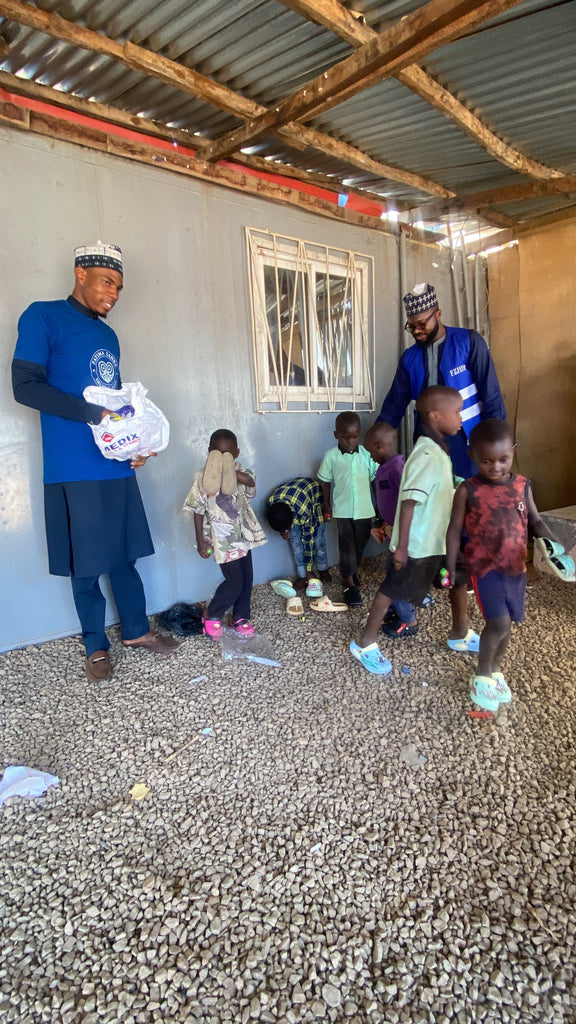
[12,242,178,682]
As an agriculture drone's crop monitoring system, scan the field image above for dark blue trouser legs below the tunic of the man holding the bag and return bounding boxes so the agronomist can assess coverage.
[71,562,150,657]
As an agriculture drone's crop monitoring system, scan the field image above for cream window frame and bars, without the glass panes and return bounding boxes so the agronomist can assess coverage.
[246,227,374,413]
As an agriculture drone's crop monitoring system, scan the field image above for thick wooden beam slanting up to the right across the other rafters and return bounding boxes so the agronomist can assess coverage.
[201,0,522,160]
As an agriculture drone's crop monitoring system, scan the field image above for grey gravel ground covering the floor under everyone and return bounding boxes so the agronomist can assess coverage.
[0,559,576,1024]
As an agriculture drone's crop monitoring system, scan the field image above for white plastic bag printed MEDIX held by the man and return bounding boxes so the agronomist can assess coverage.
[83,383,170,462]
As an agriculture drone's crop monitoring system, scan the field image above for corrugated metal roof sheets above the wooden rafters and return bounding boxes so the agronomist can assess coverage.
[0,0,576,228]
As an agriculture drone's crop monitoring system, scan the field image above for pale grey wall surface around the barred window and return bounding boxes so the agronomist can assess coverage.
[0,128,451,649]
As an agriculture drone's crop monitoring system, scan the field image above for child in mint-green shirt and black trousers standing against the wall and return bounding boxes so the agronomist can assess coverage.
[318,411,378,608]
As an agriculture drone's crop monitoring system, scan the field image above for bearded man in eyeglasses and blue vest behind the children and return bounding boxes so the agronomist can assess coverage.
[378,284,506,478]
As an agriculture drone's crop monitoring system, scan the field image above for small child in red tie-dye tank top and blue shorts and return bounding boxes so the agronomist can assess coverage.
[446,419,571,712]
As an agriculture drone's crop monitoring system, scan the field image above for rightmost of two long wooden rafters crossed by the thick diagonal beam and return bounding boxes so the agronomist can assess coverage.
[280,0,563,179]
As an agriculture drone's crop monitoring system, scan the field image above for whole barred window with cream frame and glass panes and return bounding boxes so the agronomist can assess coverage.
[247,227,374,413]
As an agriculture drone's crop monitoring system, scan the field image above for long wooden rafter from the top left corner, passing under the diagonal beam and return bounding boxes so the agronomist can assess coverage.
[0,0,454,199]
